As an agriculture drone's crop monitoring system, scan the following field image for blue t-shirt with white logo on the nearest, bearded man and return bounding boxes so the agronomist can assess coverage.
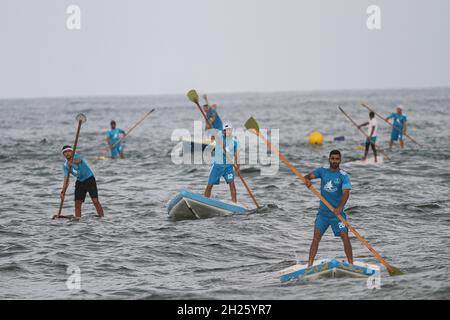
[313,167,352,217]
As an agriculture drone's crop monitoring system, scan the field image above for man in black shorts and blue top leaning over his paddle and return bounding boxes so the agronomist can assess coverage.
[61,146,104,218]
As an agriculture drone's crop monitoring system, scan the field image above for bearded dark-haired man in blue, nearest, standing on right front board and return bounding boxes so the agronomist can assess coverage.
[305,150,353,267]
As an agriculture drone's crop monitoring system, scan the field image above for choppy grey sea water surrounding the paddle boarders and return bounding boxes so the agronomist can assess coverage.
[0,89,450,299]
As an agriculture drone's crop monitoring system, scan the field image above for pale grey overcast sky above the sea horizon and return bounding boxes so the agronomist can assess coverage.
[0,0,450,98]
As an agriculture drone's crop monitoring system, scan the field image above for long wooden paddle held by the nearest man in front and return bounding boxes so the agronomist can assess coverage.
[245,117,403,276]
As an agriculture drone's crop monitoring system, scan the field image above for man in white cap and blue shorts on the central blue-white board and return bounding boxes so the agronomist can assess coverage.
[204,124,239,203]
